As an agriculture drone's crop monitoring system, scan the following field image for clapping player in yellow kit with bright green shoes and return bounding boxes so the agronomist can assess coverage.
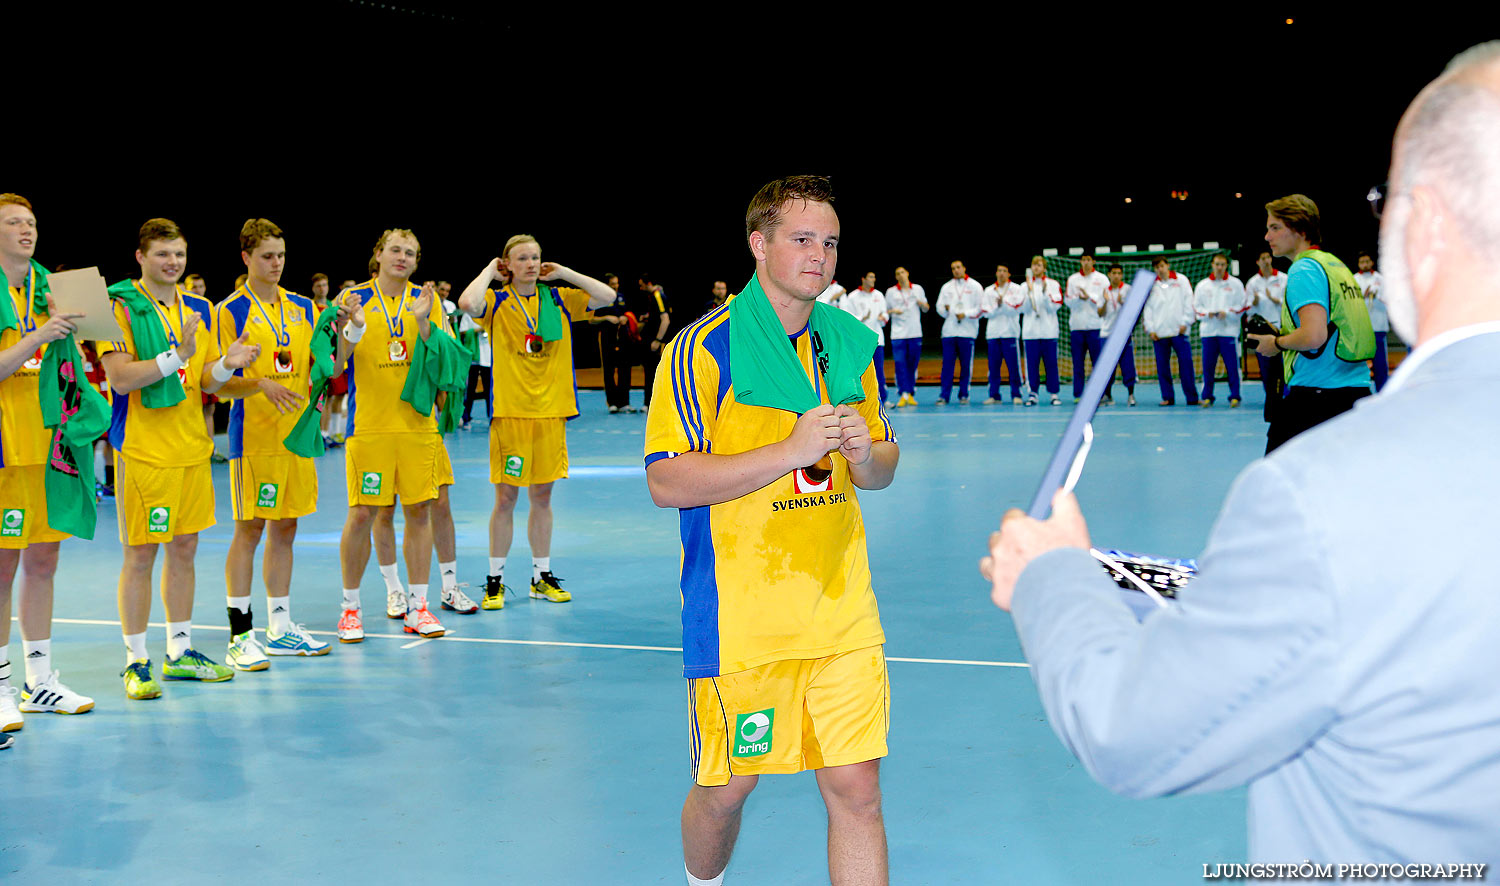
[99,219,257,699]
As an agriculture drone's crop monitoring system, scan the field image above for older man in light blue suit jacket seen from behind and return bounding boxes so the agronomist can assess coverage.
[981,42,1500,876]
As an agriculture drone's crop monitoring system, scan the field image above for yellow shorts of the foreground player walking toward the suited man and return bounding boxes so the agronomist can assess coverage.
[687,646,891,787]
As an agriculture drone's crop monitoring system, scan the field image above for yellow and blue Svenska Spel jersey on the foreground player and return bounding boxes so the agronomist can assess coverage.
[645,306,896,678]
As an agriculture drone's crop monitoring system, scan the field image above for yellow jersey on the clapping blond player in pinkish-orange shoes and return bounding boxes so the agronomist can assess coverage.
[347,280,447,436]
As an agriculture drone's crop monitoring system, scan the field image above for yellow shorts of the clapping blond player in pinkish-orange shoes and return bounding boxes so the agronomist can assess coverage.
[344,433,453,508]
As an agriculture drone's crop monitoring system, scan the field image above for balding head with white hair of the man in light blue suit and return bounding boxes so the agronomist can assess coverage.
[1380,40,1500,345]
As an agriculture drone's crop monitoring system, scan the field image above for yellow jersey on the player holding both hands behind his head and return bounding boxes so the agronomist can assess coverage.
[477,286,588,418]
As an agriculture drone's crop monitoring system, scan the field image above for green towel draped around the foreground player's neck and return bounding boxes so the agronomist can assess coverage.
[729,277,879,415]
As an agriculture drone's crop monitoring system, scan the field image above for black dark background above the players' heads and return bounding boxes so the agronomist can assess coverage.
[14,0,1496,322]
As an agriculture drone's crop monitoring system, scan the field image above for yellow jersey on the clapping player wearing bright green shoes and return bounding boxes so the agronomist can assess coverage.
[98,282,219,468]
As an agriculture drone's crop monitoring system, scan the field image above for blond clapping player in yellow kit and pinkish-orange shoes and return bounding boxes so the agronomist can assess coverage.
[339,229,453,643]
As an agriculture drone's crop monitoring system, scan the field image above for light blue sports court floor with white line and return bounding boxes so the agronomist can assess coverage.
[0,382,1265,886]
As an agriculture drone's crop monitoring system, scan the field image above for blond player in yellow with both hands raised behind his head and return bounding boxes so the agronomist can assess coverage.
[459,234,615,609]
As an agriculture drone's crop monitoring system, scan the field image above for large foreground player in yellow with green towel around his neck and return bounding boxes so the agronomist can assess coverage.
[645,175,900,885]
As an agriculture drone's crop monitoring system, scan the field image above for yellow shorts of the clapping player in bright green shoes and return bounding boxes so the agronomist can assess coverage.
[114,453,215,544]
